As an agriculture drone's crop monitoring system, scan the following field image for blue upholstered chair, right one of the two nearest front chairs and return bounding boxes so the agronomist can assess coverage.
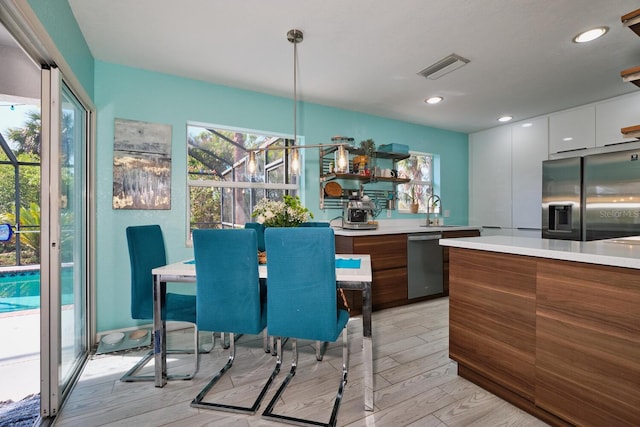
[262,227,349,426]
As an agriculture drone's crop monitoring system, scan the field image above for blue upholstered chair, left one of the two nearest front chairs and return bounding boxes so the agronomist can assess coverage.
[186,229,278,414]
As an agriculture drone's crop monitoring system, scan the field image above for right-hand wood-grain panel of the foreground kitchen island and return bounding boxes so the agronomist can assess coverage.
[536,260,640,426]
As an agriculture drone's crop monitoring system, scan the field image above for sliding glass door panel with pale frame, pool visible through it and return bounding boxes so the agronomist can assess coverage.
[41,68,90,416]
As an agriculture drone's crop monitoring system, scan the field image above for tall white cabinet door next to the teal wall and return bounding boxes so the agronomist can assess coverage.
[469,126,511,228]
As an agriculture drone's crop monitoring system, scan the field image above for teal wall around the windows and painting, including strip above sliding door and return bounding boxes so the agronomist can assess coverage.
[29,0,468,332]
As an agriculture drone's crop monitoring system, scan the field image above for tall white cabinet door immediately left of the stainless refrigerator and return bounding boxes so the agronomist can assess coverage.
[511,117,549,231]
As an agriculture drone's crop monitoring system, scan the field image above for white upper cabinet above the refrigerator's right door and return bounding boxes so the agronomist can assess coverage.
[596,92,640,147]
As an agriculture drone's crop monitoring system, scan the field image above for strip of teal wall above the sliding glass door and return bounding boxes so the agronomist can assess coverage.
[28,0,94,99]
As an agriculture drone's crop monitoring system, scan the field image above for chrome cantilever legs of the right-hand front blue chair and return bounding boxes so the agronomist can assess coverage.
[262,332,349,427]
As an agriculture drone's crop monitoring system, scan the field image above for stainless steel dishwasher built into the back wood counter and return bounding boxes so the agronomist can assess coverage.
[407,233,443,299]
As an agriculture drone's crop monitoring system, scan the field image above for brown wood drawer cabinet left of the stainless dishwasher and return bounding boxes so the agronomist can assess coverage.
[336,234,408,314]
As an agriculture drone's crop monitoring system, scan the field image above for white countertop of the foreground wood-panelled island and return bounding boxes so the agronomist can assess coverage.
[440,236,640,269]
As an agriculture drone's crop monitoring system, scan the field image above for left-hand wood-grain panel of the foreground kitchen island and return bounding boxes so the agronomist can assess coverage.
[449,248,536,402]
